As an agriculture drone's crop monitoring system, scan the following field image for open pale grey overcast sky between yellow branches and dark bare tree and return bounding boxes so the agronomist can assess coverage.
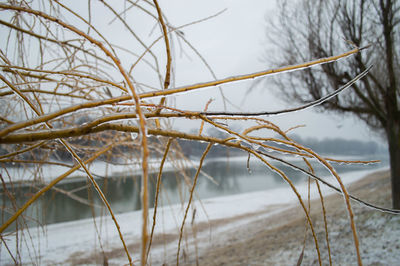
[148,0,381,141]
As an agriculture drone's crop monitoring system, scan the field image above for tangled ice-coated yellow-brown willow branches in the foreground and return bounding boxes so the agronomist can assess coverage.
[0,0,391,265]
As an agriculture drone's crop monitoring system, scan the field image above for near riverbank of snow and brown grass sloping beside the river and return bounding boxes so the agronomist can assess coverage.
[1,167,400,265]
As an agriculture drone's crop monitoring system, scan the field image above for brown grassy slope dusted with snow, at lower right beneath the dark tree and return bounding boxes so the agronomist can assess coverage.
[183,171,400,265]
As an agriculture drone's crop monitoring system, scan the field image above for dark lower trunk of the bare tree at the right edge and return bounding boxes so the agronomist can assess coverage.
[386,117,400,209]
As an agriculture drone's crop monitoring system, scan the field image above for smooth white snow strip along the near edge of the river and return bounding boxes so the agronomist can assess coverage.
[0,169,388,265]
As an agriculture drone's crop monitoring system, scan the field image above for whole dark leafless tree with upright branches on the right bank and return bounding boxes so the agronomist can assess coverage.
[268,0,400,209]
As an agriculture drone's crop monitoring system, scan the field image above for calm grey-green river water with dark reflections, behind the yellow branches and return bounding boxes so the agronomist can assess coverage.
[0,156,385,230]
